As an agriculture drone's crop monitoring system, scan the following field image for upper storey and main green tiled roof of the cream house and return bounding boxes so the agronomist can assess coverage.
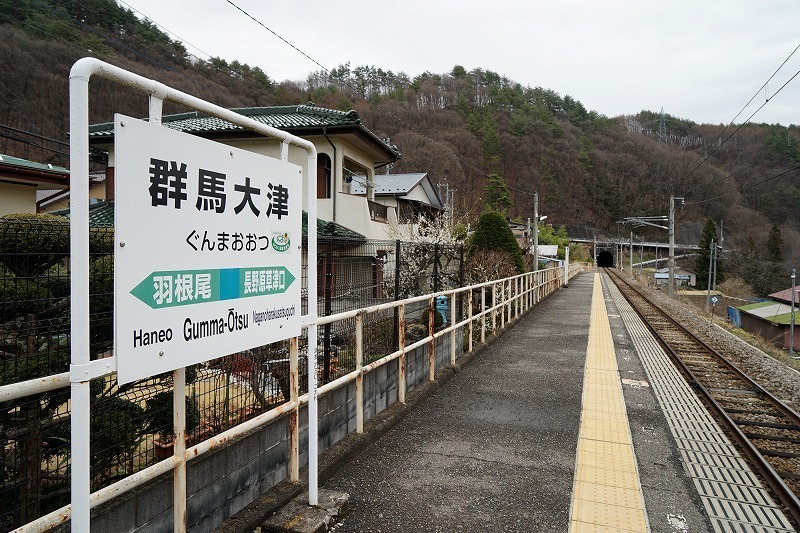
[89,103,400,239]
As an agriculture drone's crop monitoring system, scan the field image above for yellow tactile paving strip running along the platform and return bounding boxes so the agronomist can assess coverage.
[570,274,649,533]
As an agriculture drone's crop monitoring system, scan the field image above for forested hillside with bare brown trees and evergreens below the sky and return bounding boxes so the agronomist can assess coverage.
[0,0,800,290]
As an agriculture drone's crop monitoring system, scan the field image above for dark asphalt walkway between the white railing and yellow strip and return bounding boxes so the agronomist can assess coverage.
[325,273,593,532]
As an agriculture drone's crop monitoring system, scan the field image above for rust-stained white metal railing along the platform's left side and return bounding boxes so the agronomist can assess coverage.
[10,263,591,531]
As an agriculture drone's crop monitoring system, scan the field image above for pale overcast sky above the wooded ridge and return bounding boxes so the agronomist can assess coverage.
[120,0,800,125]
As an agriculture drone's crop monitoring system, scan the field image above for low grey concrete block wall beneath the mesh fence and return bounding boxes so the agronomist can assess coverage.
[75,332,462,533]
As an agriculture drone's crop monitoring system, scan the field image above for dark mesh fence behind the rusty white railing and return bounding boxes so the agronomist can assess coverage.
[0,215,464,531]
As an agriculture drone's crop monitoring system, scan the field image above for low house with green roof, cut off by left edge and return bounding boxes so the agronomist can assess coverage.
[0,154,69,216]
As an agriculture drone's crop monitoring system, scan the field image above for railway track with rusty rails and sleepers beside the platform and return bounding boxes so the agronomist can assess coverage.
[606,269,800,522]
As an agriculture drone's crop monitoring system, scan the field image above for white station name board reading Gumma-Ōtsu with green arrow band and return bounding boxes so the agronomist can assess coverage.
[114,115,302,383]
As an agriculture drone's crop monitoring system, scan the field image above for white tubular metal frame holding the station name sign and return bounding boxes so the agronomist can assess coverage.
[69,57,318,531]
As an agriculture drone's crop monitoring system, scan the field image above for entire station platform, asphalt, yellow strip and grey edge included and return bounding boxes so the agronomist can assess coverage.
[316,273,794,533]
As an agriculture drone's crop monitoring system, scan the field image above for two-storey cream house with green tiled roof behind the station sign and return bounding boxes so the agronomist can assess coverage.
[89,103,410,298]
